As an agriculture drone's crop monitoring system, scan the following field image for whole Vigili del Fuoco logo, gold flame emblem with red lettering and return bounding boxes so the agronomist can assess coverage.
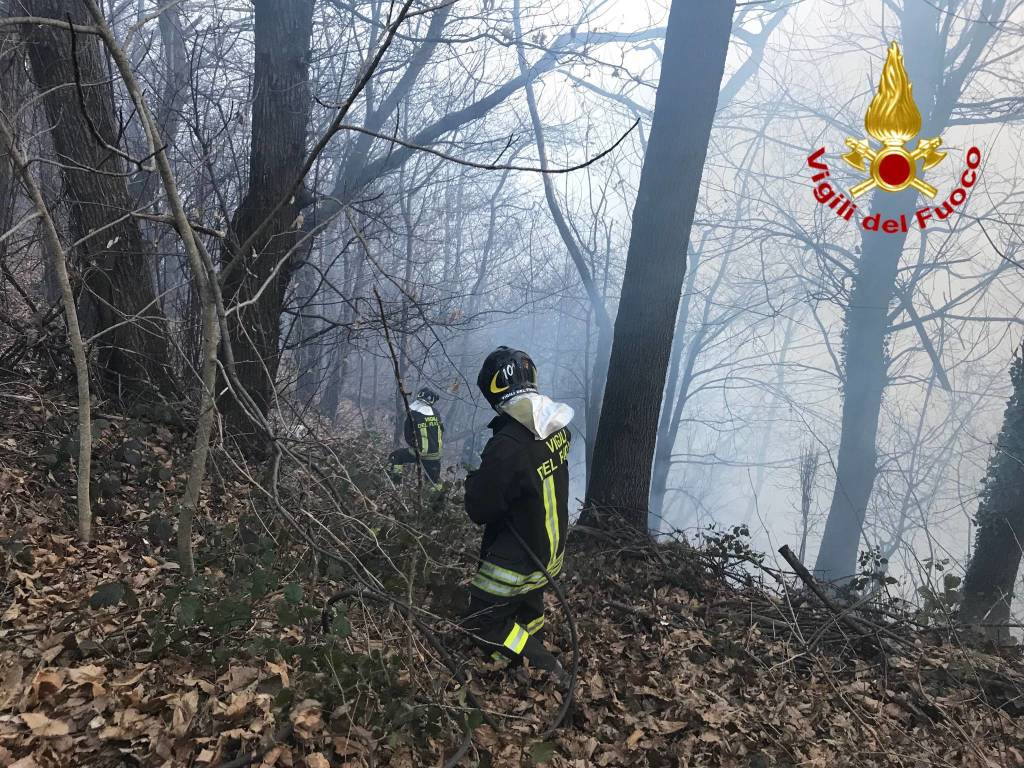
[807,43,981,233]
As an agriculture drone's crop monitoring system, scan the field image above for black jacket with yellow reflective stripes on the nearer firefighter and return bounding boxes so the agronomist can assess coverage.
[466,415,570,597]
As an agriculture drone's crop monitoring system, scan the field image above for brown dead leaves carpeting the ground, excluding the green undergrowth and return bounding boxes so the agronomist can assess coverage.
[0,393,1024,768]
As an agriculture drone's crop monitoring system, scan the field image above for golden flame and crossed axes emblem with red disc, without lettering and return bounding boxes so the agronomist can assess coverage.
[843,43,946,198]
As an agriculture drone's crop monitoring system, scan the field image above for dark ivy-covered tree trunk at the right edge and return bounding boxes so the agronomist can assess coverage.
[961,348,1024,637]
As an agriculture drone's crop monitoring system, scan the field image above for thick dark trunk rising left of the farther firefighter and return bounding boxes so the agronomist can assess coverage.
[219,0,314,452]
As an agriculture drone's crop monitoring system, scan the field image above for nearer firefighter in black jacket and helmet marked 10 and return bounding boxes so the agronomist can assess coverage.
[466,347,572,677]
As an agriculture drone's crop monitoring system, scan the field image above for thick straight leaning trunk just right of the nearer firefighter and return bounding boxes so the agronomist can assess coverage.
[586,0,735,531]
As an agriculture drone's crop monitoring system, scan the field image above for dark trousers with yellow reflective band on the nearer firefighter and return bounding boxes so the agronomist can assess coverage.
[463,587,558,671]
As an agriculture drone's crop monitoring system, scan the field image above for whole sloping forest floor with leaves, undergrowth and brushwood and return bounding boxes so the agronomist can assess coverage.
[0,376,1024,768]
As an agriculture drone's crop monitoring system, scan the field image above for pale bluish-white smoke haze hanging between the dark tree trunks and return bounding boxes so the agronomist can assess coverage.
[6,0,1024,626]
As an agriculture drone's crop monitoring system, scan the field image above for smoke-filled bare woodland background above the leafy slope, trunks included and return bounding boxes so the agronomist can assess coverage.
[0,0,1024,696]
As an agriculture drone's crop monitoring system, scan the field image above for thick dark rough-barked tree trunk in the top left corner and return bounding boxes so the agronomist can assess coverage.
[19,0,175,397]
